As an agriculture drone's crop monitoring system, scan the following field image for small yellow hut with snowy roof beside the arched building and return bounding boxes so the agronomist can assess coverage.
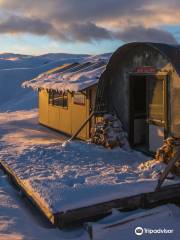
[23,57,107,140]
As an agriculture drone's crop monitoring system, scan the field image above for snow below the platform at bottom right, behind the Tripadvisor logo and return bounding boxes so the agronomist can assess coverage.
[88,204,180,240]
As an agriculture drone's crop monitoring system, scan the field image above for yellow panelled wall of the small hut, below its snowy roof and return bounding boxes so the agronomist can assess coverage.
[39,90,95,140]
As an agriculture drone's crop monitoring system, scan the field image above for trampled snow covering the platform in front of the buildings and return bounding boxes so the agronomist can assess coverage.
[0,110,178,213]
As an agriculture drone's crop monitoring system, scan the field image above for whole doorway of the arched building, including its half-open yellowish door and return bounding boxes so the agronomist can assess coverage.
[129,75,167,152]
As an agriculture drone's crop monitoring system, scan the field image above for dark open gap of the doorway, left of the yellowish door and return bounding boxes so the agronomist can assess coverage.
[130,76,148,150]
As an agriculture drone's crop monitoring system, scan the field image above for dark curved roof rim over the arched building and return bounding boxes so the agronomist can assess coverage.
[107,42,180,75]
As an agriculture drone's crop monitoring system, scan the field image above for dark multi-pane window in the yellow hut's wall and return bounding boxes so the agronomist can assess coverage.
[49,91,68,108]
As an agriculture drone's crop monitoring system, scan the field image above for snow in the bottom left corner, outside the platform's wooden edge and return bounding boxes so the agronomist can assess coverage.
[0,172,89,240]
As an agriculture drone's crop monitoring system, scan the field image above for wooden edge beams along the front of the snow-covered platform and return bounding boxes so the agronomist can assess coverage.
[0,160,180,227]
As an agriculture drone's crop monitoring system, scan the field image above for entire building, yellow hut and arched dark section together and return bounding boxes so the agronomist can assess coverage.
[24,42,180,153]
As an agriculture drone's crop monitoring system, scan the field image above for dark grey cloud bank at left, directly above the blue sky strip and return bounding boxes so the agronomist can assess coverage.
[0,16,111,42]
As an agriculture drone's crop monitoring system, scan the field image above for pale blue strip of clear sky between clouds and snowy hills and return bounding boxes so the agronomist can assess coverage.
[0,34,123,55]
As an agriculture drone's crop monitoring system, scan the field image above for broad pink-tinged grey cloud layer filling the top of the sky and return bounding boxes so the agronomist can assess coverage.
[0,0,180,43]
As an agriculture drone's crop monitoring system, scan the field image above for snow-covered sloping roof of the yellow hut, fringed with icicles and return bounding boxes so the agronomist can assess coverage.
[22,56,109,92]
